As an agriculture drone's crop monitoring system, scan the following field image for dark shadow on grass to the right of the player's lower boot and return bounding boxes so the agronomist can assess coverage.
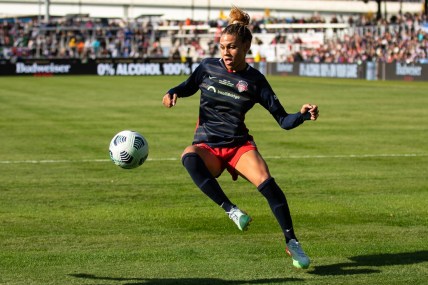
[308,250,428,275]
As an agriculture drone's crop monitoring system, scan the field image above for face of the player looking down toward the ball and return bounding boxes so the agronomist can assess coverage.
[220,34,251,71]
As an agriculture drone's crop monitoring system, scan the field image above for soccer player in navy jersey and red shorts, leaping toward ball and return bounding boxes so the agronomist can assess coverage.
[162,7,318,268]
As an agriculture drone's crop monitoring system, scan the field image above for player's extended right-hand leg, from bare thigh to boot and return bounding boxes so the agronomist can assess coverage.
[235,150,310,268]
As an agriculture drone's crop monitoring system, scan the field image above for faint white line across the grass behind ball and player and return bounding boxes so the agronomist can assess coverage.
[0,153,428,164]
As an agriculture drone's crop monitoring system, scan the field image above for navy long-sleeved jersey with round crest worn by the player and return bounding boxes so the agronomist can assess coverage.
[168,58,308,147]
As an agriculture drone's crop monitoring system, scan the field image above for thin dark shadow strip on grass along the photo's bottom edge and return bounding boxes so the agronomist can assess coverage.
[70,273,303,285]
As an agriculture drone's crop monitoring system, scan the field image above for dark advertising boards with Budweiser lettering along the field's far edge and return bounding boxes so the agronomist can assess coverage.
[0,58,428,81]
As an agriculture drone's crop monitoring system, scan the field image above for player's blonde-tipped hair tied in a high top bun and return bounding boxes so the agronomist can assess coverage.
[221,6,253,43]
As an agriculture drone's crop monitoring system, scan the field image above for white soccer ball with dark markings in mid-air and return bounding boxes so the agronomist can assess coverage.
[109,130,149,169]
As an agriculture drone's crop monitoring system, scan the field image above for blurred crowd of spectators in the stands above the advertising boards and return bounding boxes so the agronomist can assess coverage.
[0,10,428,63]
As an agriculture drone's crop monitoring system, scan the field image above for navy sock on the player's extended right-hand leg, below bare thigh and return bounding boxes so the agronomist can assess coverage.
[257,177,297,242]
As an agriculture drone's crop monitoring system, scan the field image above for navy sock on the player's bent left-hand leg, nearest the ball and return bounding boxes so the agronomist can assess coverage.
[181,152,235,212]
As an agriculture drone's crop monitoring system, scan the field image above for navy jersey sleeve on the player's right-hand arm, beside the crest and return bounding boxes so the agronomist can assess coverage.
[259,77,310,130]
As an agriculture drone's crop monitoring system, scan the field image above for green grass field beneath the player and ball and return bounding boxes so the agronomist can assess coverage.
[0,76,428,285]
